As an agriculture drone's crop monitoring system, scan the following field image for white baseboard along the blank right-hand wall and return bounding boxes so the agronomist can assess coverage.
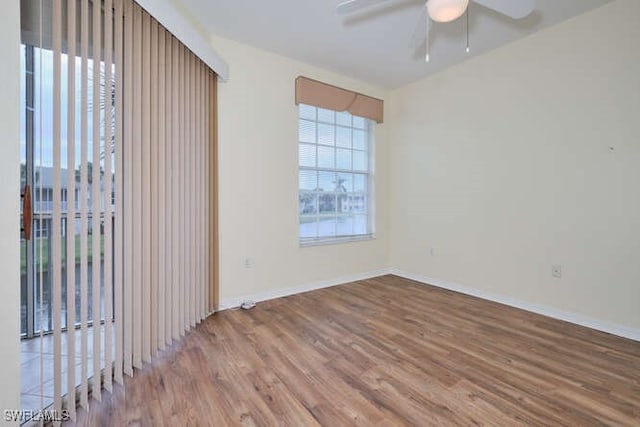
[389,268,640,341]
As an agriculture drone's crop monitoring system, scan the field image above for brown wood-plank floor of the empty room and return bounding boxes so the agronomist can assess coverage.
[72,276,640,427]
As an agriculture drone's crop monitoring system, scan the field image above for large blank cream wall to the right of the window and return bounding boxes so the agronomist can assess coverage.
[388,0,640,333]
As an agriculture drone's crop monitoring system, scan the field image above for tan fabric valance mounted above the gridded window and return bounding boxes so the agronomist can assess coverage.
[296,76,384,123]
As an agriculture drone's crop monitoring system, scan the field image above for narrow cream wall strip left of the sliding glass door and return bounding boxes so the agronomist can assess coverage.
[0,0,20,423]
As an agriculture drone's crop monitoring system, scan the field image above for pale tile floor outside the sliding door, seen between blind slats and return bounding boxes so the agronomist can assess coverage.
[20,326,104,411]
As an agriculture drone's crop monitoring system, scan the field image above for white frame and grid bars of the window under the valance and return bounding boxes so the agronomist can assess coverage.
[297,104,376,247]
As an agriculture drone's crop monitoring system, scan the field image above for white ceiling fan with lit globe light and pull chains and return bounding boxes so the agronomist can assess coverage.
[336,0,536,62]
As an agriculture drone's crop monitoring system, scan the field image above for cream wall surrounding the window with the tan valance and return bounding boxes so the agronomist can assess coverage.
[213,37,389,304]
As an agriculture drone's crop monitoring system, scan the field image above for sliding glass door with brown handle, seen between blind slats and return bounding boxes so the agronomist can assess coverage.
[20,44,113,338]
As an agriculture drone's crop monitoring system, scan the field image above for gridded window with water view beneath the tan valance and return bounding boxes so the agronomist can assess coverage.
[298,104,375,244]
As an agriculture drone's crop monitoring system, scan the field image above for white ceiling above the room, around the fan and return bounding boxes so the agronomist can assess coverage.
[176,0,610,88]
